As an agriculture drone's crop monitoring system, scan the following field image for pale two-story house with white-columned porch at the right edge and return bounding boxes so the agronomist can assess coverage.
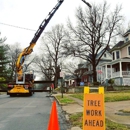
[101,30,130,85]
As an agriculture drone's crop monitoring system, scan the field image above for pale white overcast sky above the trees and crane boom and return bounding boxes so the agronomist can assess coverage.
[0,0,130,51]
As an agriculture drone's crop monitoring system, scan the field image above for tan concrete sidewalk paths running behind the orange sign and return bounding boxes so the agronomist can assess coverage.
[52,94,130,130]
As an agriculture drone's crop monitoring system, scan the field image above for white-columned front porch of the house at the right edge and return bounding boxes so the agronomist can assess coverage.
[100,58,130,85]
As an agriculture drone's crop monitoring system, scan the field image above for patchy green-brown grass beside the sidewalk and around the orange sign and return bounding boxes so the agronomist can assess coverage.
[57,91,130,130]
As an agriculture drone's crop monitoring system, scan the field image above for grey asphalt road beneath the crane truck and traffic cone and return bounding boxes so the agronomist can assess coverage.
[0,92,68,130]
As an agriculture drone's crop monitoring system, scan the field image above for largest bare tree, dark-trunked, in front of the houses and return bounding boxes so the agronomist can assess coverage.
[64,1,123,82]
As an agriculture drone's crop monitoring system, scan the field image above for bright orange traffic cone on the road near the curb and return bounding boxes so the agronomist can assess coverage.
[48,101,60,130]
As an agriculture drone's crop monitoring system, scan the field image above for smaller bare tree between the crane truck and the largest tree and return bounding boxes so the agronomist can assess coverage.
[34,25,66,87]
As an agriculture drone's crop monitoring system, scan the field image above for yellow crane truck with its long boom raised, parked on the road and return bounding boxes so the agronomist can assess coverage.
[7,0,64,96]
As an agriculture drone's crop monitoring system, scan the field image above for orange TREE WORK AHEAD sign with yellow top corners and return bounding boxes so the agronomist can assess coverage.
[83,87,105,130]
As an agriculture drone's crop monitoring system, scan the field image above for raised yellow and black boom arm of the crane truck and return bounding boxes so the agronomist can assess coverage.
[16,0,64,74]
